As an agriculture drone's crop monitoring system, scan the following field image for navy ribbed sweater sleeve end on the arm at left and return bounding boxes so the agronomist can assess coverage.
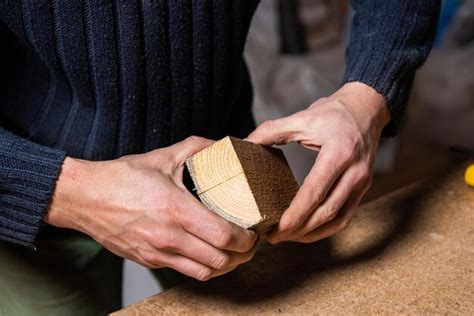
[0,127,66,247]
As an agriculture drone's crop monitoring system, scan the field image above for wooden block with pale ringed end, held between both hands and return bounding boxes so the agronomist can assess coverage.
[186,137,298,233]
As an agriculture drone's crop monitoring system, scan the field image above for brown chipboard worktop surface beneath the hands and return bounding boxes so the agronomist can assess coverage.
[115,166,474,315]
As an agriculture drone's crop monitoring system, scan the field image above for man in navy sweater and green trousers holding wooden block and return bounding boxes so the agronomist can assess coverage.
[0,0,439,315]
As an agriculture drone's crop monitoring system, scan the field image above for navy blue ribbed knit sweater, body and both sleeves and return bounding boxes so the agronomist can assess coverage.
[0,0,438,246]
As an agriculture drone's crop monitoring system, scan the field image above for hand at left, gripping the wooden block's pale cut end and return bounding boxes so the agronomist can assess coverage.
[45,137,257,280]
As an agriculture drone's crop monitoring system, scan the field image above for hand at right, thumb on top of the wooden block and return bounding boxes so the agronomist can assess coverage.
[247,82,390,243]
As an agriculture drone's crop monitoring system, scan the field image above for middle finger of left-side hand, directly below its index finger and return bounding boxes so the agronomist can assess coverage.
[175,232,257,270]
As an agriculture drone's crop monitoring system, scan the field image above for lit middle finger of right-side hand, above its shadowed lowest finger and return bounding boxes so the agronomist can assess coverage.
[294,166,369,236]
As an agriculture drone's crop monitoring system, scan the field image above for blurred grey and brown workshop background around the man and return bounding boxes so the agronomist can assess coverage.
[124,0,474,306]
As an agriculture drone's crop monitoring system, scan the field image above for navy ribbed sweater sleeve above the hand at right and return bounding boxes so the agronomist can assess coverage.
[343,0,440,136]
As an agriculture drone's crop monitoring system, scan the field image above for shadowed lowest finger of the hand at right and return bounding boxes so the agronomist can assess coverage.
[295,179,370,243]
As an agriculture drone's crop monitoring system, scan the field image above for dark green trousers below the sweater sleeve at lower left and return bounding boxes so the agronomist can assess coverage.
[0,232,184,316]
